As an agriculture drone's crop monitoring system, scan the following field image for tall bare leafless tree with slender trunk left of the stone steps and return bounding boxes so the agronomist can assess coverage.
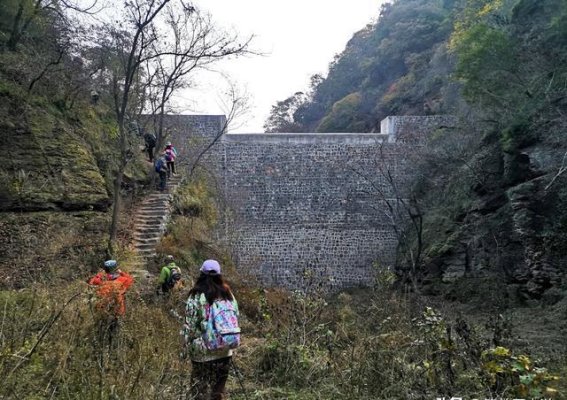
[98,0,252,254]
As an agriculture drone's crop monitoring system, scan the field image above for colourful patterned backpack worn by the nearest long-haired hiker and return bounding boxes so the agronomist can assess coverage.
[201,300,240,351]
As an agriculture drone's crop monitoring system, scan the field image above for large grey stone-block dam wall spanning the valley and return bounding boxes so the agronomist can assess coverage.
[161,116,458,288]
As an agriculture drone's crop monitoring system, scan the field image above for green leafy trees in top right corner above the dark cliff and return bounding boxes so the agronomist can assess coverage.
[451,0,567,126]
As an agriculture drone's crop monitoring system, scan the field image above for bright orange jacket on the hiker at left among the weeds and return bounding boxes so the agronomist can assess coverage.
[89,271,134,316]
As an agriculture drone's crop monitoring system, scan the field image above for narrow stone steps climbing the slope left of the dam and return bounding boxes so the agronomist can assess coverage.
[133,175,181,263]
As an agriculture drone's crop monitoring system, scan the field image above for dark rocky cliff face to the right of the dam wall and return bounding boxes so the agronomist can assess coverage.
[423,133,567,304]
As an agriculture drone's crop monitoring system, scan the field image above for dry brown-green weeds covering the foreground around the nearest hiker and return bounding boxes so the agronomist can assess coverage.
[0,276,565,400]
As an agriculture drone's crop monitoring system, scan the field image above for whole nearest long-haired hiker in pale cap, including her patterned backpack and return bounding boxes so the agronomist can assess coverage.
[182,260,240,400]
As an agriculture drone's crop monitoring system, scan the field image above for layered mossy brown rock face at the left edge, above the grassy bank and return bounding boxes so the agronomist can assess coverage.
[0,93,110,211]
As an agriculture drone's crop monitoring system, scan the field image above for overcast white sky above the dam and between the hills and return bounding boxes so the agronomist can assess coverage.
[180,0,385,133]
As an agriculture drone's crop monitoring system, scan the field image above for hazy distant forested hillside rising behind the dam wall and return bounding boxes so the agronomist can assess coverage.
[270,0,460,132]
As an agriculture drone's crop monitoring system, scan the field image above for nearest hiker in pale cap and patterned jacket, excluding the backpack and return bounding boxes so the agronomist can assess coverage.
[182,260,238,400]
